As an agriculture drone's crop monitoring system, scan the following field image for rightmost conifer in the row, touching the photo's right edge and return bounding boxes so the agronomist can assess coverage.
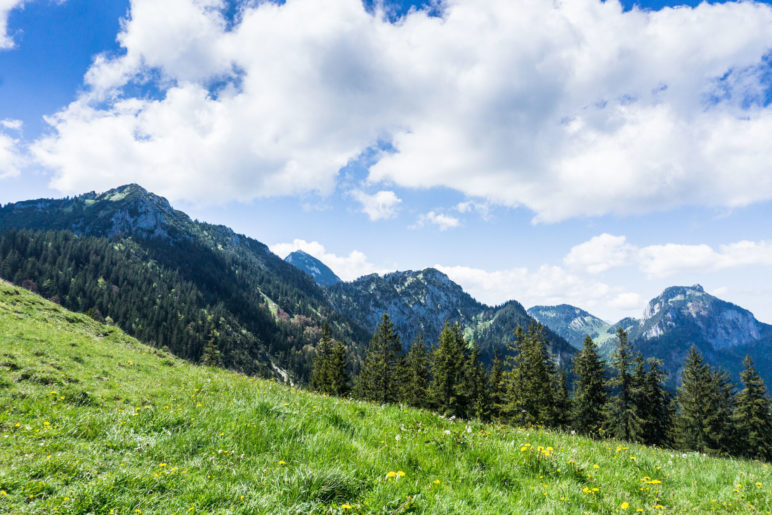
[733,356,772,461]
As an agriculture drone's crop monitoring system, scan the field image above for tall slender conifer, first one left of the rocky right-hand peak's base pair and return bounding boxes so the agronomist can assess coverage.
[606,327,635,440]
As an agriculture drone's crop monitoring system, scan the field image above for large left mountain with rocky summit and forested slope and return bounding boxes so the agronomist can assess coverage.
[0,184,370,381]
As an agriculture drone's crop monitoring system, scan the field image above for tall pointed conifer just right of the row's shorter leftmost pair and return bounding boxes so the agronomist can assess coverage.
[356,313,402,403]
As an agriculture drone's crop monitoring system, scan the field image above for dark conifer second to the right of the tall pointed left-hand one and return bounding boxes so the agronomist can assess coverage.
[430,322,469,417]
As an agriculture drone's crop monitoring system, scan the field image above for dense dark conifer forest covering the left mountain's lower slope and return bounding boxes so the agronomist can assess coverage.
[0,230,364,381]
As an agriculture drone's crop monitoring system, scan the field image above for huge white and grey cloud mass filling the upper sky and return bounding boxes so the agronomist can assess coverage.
[34,0,772,222]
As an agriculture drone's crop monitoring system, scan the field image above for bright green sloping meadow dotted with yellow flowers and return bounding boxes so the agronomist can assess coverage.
[0,283,772,514]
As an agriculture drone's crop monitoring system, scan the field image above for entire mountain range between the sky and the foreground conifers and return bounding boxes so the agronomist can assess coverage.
[0,184,772,383]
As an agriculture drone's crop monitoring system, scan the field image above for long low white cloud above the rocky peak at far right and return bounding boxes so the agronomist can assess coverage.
[563,233,772,278]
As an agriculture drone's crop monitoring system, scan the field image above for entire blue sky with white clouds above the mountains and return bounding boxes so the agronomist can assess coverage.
[0,0,772,322]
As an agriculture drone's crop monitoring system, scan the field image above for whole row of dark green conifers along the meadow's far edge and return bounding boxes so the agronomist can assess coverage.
[311,314,772,461]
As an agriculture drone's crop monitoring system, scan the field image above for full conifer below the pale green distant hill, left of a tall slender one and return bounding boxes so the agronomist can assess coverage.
[571,336,608,436]
